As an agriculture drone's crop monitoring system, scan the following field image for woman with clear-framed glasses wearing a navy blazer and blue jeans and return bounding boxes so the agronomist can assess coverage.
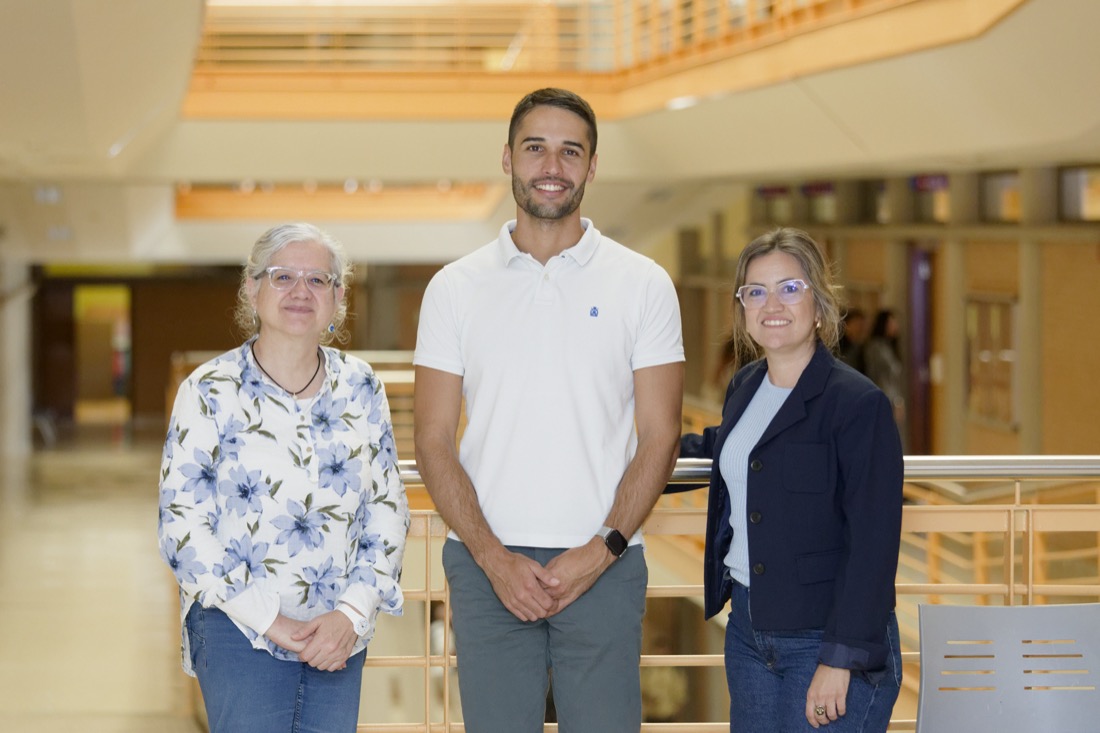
[680,228,902,733]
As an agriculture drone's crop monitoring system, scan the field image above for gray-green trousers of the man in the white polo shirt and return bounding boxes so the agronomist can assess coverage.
[443,539,649,733]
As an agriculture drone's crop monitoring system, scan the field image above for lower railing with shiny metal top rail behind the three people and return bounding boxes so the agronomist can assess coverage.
[349,456,1100,733]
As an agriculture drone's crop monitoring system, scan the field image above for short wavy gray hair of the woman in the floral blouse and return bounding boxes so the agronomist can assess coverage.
[233,222,352,343]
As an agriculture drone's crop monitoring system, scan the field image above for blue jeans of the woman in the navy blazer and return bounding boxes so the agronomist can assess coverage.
[726,583,901,733]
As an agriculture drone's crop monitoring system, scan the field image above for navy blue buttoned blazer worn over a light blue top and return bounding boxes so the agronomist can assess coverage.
[670,344,904,670]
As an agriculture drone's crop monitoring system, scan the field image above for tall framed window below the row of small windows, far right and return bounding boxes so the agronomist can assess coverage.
[966,296,1016,429]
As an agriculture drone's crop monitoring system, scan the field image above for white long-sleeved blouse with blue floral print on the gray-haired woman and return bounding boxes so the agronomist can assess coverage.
[158,341,409,675]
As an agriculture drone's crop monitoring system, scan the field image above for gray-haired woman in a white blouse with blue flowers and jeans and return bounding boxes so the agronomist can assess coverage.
[158,223,409,733]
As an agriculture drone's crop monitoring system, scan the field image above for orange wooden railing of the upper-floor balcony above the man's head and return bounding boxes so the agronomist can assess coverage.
[196,0,916,75]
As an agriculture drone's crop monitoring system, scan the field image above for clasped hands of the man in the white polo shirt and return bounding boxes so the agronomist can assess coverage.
[483,537,615,621]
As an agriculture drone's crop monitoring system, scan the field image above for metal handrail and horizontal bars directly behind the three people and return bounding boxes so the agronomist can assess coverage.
[376,456,1100,733]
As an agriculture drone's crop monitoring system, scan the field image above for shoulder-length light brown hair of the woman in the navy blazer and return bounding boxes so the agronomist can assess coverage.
[733,227,842,367]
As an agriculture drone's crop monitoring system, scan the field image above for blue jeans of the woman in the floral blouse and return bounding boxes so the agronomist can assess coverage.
[187,603,366,733]
